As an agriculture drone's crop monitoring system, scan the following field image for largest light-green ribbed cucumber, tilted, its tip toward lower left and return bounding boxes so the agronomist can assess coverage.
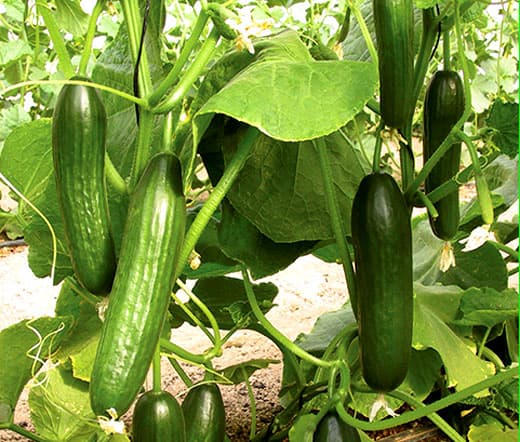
[90,154,186,416]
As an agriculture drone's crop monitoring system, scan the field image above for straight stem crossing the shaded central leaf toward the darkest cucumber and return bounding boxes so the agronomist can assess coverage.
[312,138,357,315]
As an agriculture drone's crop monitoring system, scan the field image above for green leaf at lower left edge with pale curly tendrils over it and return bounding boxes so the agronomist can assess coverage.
[0,317,72,423]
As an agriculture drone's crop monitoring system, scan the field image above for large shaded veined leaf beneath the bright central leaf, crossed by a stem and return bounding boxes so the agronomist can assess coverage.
[224,132,365,243]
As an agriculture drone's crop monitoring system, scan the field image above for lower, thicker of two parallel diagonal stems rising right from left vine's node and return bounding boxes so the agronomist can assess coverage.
[153,29,219,113]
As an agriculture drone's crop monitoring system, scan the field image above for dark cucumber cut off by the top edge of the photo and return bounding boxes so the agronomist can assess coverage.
[373,0,414,129]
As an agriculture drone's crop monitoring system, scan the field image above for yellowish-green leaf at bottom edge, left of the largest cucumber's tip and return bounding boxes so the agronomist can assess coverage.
[29,367,99,442]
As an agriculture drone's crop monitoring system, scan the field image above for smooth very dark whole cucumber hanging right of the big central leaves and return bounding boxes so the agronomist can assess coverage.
[352,173,413,392]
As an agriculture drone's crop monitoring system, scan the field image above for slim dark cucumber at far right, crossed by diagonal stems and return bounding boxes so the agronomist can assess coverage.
[423,71,464,241]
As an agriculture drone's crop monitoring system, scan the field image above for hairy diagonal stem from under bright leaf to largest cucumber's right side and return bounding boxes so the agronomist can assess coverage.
[175,126,259,275]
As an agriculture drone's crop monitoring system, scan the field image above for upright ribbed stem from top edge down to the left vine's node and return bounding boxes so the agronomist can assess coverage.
[121,0,152,97]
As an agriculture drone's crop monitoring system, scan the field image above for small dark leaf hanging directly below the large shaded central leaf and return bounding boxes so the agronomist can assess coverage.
[218,200,315,279]
